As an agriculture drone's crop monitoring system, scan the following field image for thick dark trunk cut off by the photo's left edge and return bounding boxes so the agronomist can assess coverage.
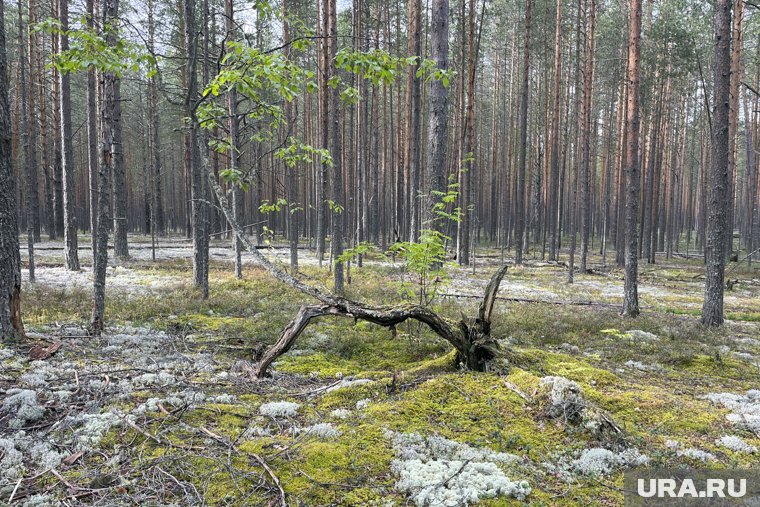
[0,2,24,341]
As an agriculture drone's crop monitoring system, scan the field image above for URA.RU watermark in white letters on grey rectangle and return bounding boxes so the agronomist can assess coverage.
[624,469,760,507]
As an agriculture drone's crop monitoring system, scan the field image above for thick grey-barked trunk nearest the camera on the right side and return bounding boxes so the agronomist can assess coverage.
[702,0,731,326]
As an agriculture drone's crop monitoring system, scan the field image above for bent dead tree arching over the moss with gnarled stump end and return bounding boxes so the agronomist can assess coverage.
[209,174,507,377]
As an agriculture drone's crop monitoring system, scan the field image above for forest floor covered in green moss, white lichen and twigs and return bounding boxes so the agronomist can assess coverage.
[0,237,760,506]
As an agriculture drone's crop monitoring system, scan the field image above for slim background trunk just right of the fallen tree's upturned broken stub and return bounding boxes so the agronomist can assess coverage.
[515,0,531,265]
